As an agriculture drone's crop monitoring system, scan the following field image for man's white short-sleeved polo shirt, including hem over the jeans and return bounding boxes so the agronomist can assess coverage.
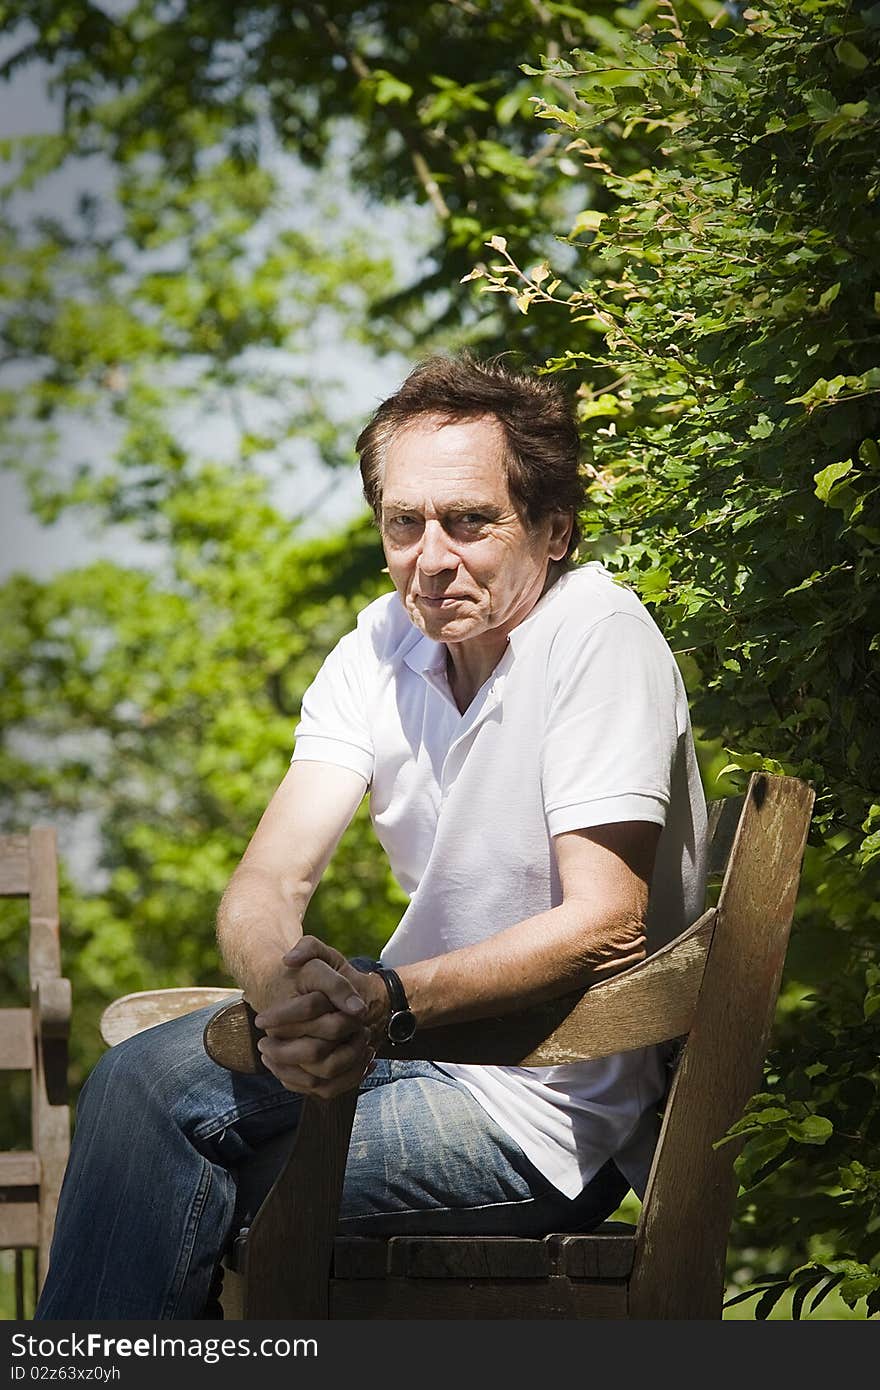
[293,564,706,1197]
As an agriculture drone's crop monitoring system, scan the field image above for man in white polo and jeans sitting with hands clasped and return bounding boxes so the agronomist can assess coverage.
[38,357,705,1319]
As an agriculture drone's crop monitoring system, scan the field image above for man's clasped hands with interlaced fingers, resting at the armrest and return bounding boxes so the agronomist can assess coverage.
[248,937,388,1099]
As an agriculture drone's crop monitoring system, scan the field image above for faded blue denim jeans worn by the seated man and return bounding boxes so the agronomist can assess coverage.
[35,1005,628,1321]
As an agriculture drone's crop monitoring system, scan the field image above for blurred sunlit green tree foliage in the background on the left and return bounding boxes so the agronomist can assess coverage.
[0,0,689,1076]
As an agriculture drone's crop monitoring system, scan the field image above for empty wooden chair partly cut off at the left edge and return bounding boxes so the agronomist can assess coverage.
[0,826,71,1318]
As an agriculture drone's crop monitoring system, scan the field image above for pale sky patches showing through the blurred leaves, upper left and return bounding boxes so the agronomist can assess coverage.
[0,39,430,581]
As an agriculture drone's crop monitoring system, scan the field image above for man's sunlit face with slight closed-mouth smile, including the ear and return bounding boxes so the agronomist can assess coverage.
[382,416,570,648]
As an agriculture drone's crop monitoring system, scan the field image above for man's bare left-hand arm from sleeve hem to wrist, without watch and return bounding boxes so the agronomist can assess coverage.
[217,762,366,1009]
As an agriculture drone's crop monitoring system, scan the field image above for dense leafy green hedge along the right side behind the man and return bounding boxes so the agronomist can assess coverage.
[492,0,880,1318]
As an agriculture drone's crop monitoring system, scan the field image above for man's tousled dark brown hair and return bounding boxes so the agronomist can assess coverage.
[356,353,584,563]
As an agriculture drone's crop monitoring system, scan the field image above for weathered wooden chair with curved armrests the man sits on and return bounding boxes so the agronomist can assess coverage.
[99,774,813,1319]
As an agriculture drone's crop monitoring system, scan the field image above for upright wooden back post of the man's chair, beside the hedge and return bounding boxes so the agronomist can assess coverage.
[630,774,815,1318]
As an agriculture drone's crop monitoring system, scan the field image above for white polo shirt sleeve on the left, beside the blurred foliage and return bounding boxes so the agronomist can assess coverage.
[291,631,373,785]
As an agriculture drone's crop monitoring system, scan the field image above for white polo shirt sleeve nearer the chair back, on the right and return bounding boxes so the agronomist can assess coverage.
[541,612,678,835]
